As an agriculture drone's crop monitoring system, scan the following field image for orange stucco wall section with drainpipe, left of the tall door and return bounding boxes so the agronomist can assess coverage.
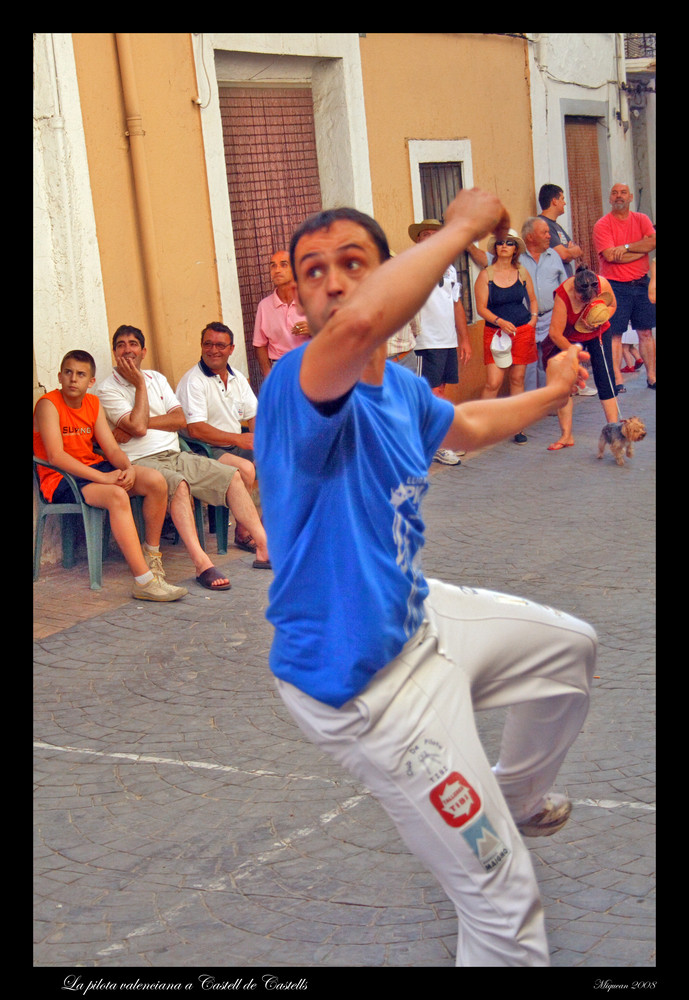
[73,32,222,385]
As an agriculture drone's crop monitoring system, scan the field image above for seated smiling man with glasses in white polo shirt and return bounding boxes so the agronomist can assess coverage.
[176,322,258,552]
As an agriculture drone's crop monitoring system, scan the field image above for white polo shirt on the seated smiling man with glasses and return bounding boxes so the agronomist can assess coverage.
[177,360,258,434]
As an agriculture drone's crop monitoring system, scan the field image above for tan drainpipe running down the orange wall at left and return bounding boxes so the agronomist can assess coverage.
[115,33,172,378]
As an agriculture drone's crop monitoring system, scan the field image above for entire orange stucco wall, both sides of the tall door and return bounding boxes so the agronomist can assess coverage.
[68,33,536,393]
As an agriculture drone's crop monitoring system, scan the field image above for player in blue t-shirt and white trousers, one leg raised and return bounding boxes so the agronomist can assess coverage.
[254,190,596,966]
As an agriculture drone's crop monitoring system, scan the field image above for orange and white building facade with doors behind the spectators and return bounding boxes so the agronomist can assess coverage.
[34,32,655,564]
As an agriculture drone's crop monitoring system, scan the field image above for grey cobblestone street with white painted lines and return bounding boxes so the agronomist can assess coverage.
[34,372,656,986]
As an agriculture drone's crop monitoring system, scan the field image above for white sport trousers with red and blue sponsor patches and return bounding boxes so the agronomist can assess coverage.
[277,580,596,967]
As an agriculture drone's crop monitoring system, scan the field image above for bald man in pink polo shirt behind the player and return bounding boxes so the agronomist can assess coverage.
[254,250,309,378]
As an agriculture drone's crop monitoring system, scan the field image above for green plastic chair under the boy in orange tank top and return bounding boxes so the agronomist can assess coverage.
[33,455,145,590]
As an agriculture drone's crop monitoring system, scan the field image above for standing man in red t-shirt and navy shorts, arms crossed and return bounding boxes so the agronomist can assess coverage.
[593,183,656,392]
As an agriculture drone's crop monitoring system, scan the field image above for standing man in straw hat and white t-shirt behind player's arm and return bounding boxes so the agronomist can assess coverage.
[409,219,471,465]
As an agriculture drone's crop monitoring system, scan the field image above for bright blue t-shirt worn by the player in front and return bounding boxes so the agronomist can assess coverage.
[254,347,454,708]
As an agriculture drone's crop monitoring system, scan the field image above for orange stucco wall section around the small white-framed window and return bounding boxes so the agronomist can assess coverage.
[360,32,538,399]
